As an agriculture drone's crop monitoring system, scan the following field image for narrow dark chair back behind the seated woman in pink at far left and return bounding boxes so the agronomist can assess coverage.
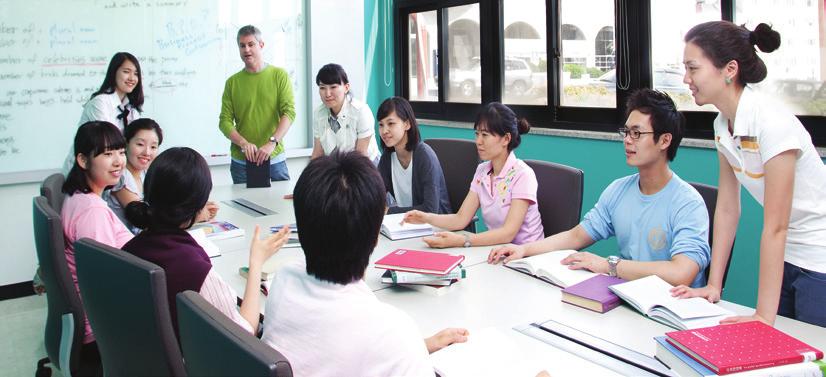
[32,196,85,375]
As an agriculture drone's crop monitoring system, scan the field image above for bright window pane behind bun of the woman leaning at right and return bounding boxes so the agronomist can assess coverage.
[734,0,826,116]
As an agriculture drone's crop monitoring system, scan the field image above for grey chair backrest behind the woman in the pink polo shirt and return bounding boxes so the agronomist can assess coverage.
[525,160,585,237]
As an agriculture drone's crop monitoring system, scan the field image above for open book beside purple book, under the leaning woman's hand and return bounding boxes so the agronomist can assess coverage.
[609,275,734,330]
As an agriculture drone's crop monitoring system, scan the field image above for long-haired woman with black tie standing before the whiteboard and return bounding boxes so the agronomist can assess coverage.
[63,52,143,172]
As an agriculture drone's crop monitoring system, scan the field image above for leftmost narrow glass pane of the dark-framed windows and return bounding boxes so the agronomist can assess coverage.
[408,11,439,102]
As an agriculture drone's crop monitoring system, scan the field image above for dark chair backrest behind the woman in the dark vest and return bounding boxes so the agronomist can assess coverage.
[75,238,185,376]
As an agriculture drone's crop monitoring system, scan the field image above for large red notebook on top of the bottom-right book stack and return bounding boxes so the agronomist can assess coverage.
[665,321,823,374]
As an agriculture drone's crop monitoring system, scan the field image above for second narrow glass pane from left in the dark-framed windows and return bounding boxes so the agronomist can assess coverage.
[445,3,482,103]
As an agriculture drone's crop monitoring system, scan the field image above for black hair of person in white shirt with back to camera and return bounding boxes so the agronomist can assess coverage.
[293,151,386,284]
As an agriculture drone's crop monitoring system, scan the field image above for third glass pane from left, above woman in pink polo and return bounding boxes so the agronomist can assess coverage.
[502,0,548,106]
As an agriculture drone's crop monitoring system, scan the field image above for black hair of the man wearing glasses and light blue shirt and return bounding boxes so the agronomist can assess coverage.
[625,88,685,161]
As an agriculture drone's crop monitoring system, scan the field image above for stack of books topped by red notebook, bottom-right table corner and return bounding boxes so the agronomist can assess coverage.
[654,321,826,376]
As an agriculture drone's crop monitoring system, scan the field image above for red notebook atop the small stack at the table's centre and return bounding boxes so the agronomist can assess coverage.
[376,249,465,275]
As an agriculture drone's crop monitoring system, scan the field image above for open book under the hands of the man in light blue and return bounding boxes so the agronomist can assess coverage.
[505,250,596,288]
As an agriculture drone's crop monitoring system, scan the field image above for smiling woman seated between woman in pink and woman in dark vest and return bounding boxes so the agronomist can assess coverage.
[104,118,163,233]
